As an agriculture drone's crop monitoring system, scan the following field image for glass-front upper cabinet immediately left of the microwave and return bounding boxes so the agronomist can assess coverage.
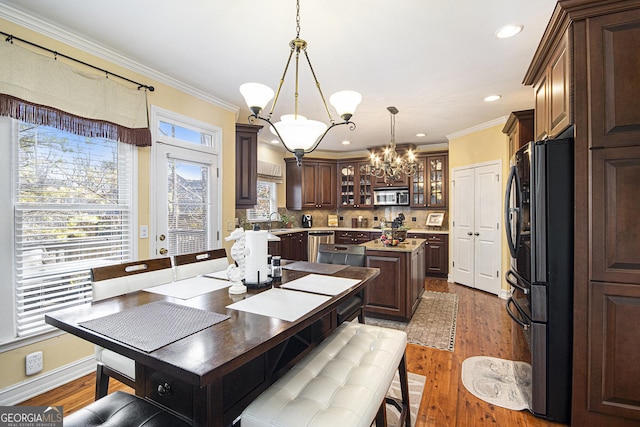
[338,161,373,209]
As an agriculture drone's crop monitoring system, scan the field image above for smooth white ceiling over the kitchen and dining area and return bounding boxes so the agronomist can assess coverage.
[0,0,556,151]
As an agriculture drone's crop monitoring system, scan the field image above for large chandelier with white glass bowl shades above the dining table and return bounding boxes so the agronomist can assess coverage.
[240,0,362,166]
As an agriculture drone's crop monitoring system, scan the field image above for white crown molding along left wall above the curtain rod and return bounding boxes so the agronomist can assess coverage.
[0,3,240,116]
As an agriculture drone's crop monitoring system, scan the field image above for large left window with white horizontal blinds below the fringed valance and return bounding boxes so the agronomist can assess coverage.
[0,117,134,341]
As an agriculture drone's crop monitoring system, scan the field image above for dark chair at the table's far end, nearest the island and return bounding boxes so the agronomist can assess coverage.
[316,243,367,325]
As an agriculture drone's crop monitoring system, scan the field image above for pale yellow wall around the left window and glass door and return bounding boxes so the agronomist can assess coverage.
[0,19,236,391]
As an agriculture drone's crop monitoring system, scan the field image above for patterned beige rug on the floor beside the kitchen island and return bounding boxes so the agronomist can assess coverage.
[365,291,458,351]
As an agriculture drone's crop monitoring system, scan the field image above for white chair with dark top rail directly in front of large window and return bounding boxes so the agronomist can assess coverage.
[91,258,173,400]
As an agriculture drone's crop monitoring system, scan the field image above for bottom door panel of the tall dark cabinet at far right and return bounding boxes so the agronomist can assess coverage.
[588,282,640,420]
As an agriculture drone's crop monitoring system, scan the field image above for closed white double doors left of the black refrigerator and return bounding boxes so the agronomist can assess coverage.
[452,162,502,295]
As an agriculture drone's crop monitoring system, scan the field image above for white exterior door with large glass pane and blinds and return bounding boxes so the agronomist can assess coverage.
[155,143,219,256]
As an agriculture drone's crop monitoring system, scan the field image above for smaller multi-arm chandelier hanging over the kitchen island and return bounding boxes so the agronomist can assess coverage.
[370,107,418,183]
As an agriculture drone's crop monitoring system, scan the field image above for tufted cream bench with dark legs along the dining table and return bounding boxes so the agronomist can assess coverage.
[241,322,411,427]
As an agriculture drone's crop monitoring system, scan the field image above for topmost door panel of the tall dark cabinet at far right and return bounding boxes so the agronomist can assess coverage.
[588,10,640,147]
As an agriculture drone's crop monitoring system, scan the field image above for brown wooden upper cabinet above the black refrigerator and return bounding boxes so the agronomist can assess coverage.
[525,26,573,141]
